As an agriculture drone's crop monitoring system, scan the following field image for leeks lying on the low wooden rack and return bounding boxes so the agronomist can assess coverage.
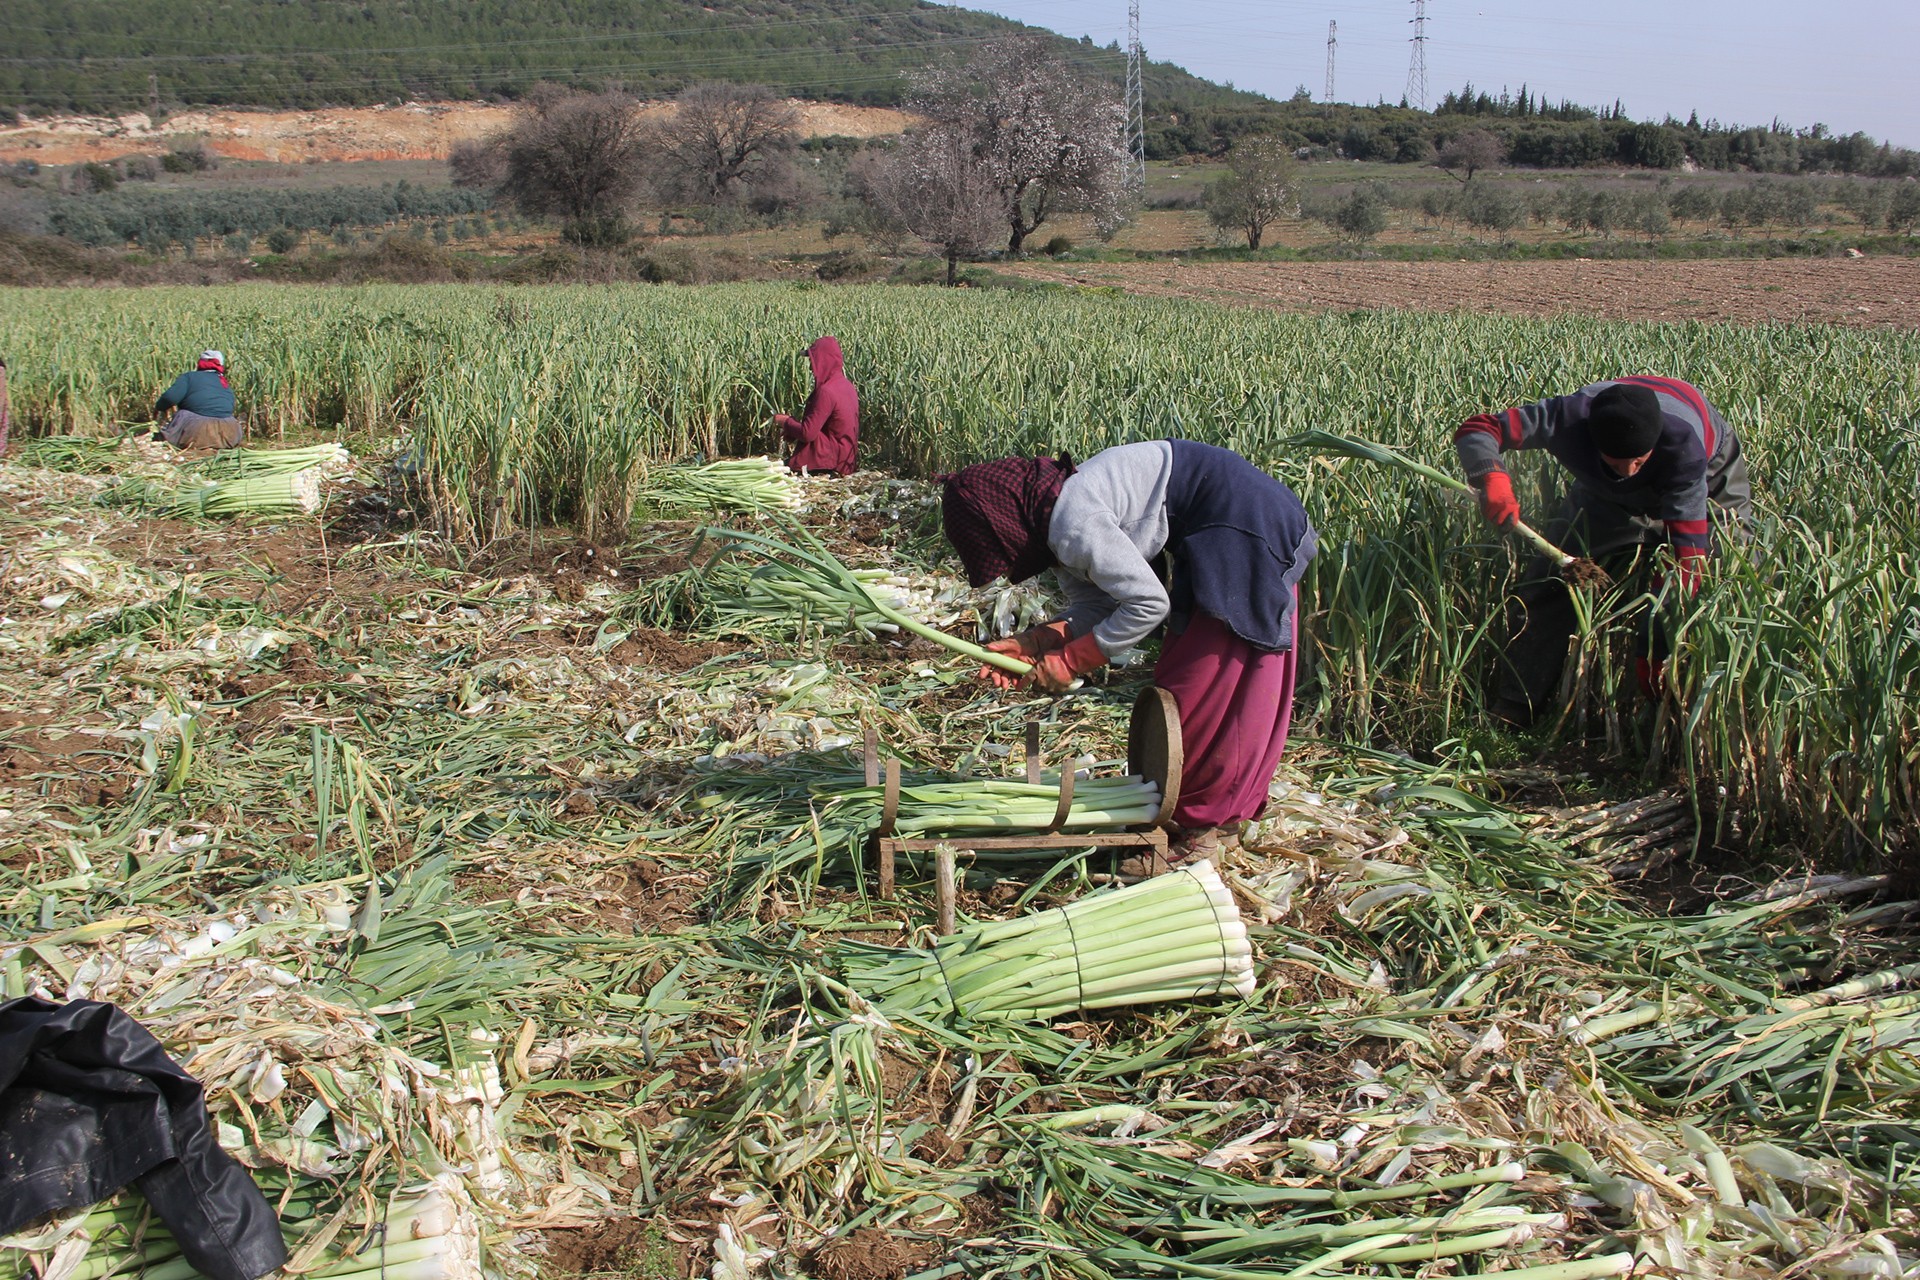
[814,773,1160,837]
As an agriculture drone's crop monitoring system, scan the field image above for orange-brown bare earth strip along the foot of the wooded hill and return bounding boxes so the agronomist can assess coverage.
[0,100,908,165]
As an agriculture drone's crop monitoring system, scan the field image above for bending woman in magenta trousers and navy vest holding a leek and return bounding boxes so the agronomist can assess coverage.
[943,439,1317,856]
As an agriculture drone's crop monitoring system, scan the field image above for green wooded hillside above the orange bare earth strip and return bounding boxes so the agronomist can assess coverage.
[0,0,1271,115]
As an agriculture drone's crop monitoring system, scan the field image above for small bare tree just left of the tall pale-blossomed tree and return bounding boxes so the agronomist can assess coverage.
[864,125,1006,284]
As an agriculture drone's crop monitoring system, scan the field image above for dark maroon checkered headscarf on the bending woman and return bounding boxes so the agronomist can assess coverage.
[941,453,1073,587]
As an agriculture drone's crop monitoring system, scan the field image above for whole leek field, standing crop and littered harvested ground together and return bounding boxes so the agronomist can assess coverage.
[0,286,1920,1280]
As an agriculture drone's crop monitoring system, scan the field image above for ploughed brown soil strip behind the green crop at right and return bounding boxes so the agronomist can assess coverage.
[1002,257,1920,328]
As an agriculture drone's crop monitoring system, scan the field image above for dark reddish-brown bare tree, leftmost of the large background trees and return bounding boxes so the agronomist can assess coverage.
[464,84,643,244]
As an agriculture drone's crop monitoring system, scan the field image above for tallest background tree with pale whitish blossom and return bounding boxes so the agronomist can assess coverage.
[910,36,1127,253]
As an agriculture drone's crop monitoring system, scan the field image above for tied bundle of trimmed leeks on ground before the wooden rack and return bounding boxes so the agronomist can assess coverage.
[841,862,1254,1021]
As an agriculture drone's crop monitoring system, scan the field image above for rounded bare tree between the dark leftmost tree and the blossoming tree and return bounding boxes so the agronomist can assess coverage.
[649,83,801,205]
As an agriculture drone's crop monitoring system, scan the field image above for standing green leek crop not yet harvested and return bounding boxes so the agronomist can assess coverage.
[0,286,1920,862]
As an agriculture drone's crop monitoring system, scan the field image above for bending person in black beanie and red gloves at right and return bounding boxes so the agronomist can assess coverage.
[1453,378,1753,725]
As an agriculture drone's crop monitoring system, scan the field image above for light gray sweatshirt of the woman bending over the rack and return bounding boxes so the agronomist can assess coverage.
[1046,439,1173,658]
